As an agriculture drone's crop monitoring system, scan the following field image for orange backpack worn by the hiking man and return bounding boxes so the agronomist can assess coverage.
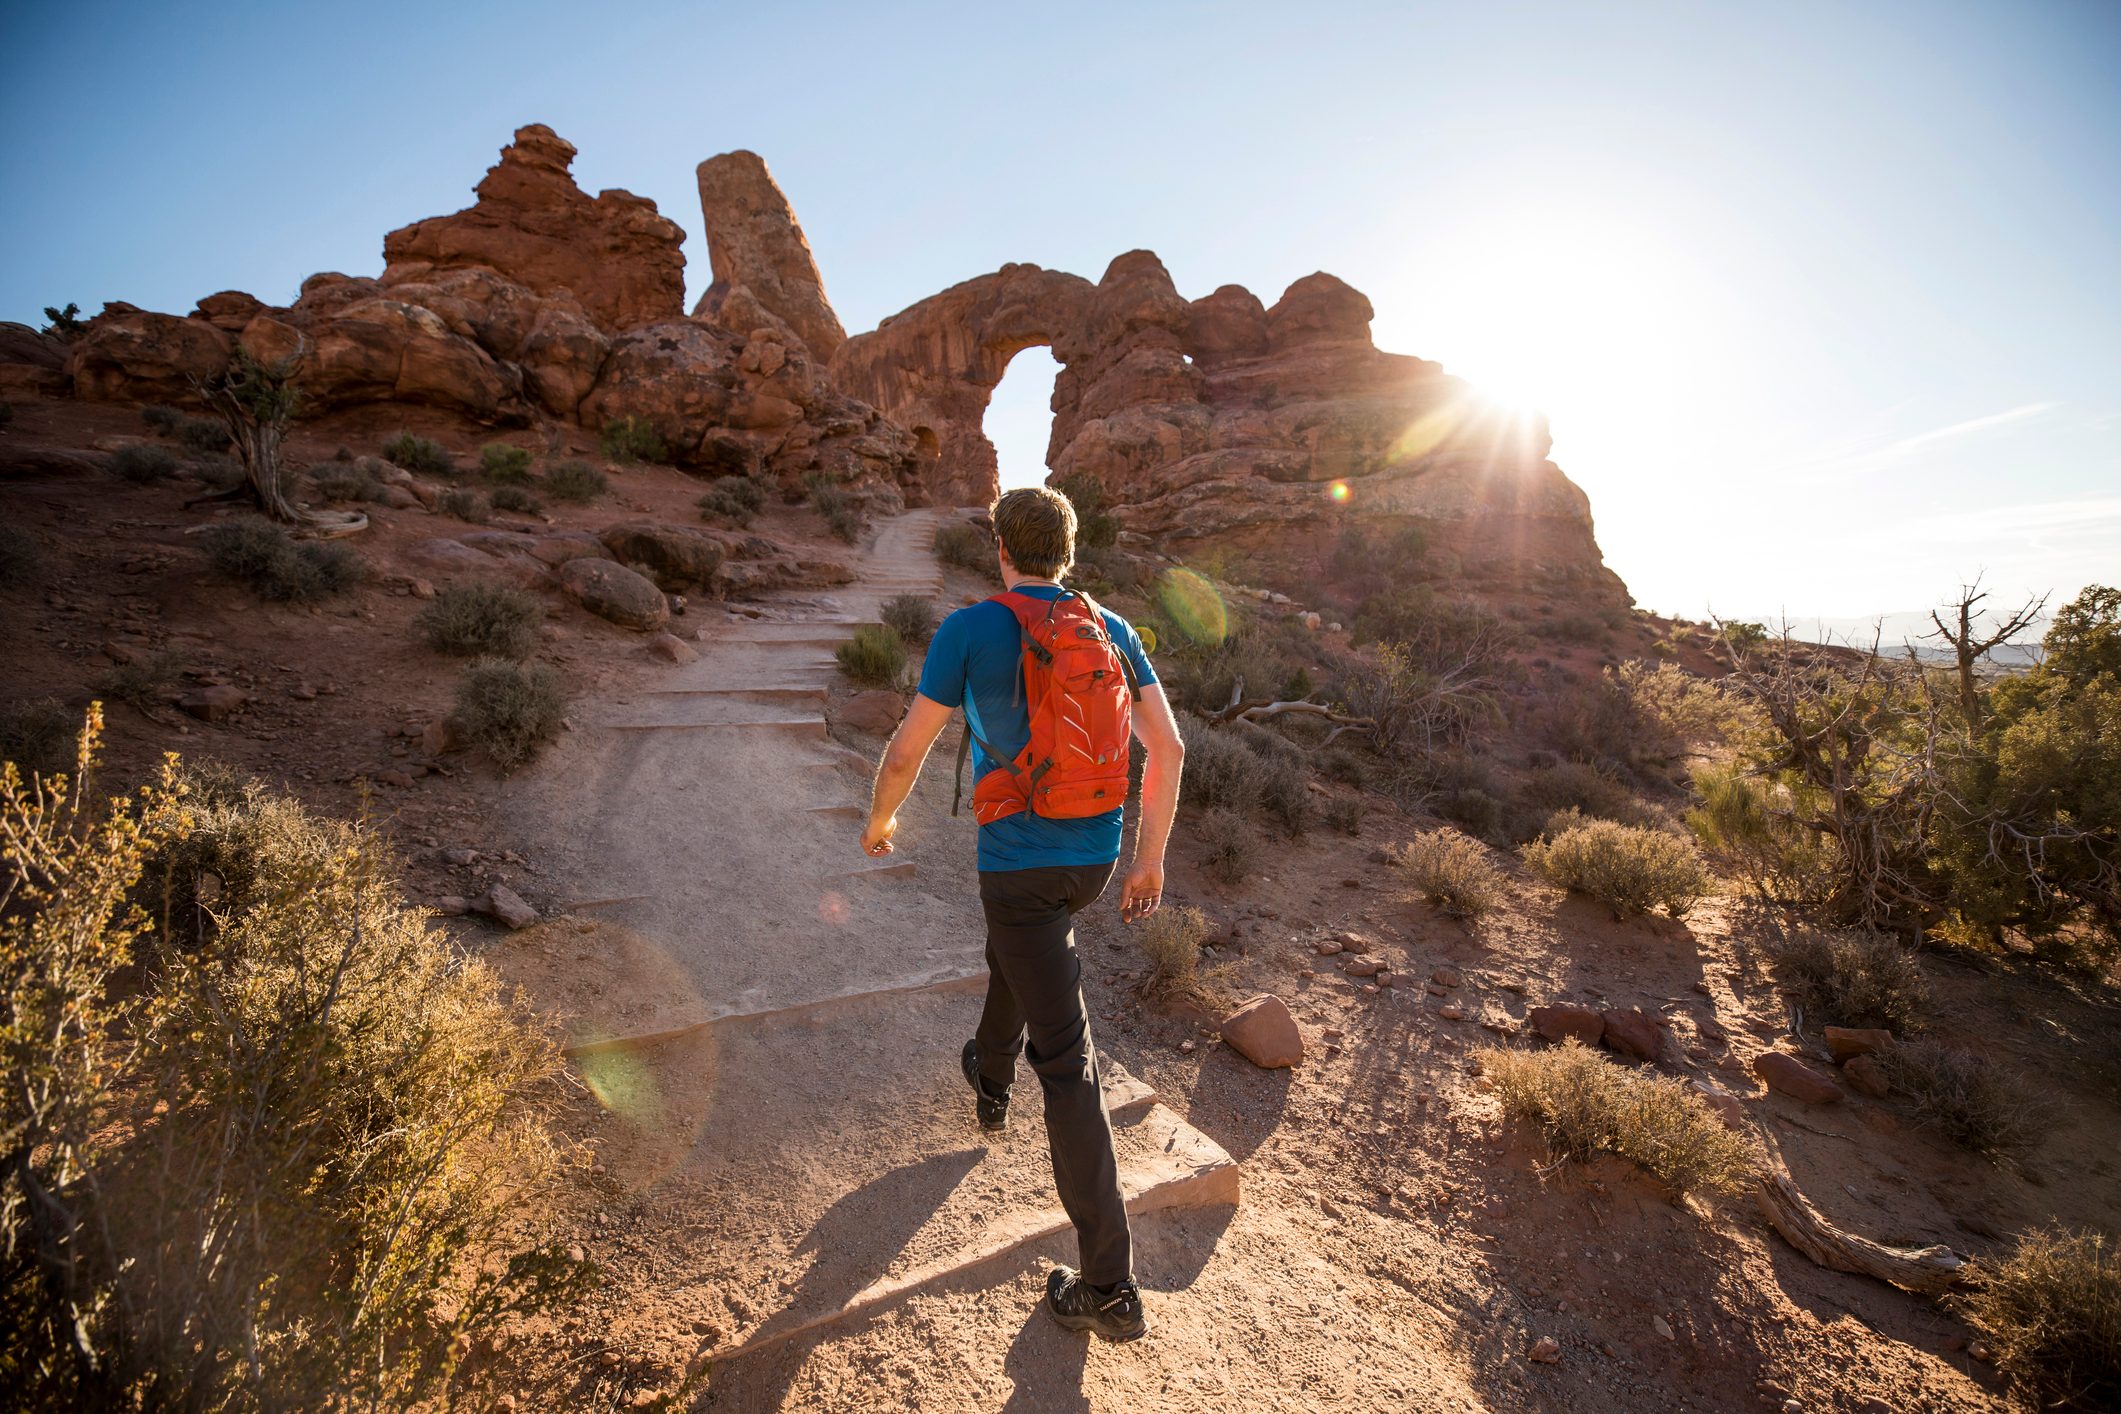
[950,589,1141,825]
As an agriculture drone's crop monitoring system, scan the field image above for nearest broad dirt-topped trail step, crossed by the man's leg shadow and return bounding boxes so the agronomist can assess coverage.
[547,986,1239,1361]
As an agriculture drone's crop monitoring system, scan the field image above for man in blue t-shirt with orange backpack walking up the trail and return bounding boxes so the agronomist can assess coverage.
[861,488,1186,1340]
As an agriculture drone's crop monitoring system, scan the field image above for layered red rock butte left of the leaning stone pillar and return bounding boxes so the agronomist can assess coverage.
[382,123,685,333]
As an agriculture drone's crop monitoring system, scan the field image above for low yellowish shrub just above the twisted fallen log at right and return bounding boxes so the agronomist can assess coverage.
[1474,1037,1754,1194]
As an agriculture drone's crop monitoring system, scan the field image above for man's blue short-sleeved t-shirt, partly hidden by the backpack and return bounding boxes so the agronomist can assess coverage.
[921,585,1156,873]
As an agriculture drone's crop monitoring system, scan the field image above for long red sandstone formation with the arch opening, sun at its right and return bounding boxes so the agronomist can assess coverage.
[831,250,1625,598]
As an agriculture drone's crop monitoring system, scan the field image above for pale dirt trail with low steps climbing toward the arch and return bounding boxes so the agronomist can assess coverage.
[485,511,1237,1390]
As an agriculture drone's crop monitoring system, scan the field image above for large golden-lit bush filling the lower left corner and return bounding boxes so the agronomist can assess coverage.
[0,717,594,1410]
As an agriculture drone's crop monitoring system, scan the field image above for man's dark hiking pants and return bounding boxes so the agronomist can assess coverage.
[978,865,1135,1287]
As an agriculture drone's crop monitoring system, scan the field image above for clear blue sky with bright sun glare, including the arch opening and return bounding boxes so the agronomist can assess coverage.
[0,0,2121,631]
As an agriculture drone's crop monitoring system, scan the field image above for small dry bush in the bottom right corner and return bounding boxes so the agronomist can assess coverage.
[1960,1227,2121,1414]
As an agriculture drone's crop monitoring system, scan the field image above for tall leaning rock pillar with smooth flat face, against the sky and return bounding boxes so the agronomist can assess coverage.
[694,151,846,365]
